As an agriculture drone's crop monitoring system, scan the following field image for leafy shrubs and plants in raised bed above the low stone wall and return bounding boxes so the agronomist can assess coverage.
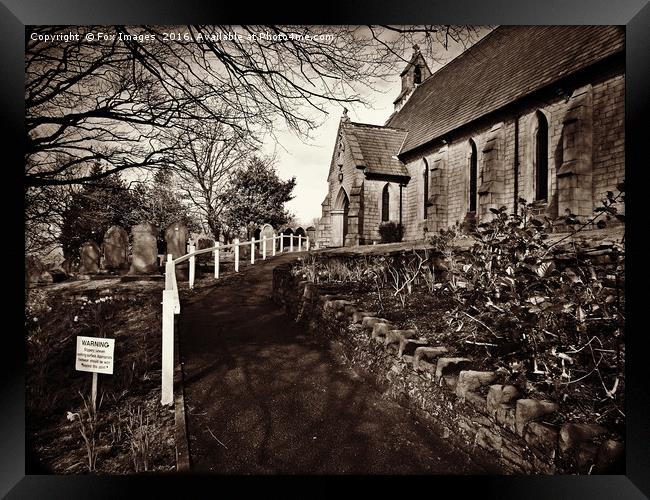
[296,184,625,415]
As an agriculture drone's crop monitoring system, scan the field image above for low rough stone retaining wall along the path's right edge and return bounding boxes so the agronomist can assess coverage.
[273,264,624,474]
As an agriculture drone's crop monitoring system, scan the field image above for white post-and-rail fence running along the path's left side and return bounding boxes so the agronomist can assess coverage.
[161,234,309,405]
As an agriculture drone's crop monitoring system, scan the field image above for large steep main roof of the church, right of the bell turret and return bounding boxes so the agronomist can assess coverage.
[386,26,625,153]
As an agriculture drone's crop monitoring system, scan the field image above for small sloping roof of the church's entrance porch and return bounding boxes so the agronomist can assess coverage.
[343,121,409,177]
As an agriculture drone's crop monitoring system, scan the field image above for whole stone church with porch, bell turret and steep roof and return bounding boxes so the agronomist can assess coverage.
[316,26,625,247]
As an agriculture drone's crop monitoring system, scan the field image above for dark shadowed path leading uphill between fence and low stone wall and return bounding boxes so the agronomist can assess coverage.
[179,254,496,474]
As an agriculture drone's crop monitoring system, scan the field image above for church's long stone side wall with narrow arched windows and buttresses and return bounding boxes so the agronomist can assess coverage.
[403,60,625,240]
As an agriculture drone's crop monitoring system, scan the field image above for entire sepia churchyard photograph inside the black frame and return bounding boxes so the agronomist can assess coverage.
[24,25,627,476]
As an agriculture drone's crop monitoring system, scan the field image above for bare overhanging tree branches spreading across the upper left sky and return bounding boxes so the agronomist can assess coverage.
[25,26,475,254]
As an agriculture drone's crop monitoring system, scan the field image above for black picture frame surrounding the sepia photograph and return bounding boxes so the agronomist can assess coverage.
[6,0,650,499]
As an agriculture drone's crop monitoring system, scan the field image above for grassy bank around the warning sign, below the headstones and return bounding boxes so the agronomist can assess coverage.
[26,280,176,474]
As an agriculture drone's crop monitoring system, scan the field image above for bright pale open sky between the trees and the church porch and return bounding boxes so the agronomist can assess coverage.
[264,29,489,226]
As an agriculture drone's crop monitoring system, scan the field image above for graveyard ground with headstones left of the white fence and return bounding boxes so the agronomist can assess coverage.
[25,217,314,474]
